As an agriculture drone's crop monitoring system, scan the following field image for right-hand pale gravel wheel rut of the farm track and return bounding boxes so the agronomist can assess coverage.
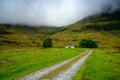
[52,50,92,80]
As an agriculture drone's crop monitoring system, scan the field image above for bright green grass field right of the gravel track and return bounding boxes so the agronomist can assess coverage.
[73,50,120,80]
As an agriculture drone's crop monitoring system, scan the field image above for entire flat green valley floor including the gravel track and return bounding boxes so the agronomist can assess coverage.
[0,48,120,80]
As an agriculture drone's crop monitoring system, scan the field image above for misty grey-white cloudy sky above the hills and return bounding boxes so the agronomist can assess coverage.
[0,0,120,26]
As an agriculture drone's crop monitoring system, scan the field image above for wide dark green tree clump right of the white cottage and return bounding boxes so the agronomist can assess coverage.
[79,39,98,48]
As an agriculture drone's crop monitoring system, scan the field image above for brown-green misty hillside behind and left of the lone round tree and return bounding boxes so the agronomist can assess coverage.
[0,24,61,49]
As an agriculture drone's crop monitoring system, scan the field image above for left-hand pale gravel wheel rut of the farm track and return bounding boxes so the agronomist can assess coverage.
[14,51,87,80]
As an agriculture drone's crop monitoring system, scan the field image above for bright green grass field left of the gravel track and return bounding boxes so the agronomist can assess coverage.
[0,48,84,80]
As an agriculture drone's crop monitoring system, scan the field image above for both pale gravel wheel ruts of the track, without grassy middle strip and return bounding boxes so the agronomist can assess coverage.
[15,50,92,80]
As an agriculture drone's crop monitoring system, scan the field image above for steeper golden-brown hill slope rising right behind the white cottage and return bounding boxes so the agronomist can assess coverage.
[52,11,120,48]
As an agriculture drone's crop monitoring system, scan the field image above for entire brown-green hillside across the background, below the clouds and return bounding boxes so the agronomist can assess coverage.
[0,11,120,49]
